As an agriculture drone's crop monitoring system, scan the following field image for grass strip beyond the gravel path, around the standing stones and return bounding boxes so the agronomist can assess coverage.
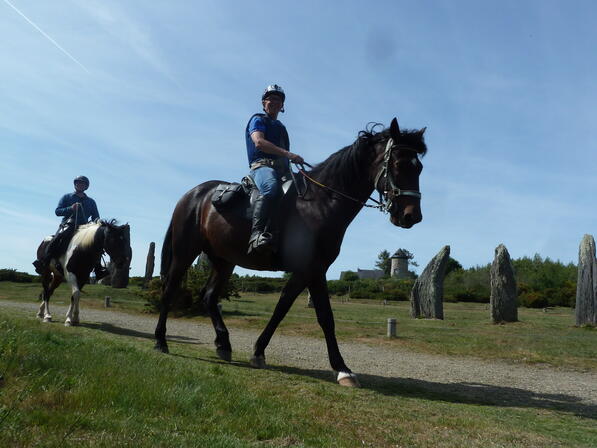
[0,282,597,370]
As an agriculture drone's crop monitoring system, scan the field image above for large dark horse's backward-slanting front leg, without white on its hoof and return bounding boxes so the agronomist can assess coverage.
[250,273,306,368]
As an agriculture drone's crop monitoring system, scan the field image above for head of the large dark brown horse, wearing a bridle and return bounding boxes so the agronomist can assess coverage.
[375,118,427,229]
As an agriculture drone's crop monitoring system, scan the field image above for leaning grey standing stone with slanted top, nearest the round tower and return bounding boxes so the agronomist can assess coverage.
[410,246,450,319]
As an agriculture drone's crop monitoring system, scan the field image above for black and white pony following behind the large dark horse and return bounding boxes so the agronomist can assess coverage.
[37,220,132,327]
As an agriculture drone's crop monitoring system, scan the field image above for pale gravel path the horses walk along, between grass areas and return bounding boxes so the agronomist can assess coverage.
[0,300,597,419]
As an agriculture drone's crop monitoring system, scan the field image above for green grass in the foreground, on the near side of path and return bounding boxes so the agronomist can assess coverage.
[0,309,597,448]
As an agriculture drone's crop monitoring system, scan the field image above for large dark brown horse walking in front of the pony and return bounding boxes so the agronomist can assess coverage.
[155,118,427,386]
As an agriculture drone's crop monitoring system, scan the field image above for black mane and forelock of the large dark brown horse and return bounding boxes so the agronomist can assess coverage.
[311,123,427,189]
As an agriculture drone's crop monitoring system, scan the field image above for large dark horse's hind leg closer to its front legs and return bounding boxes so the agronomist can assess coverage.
[203,259,234,361]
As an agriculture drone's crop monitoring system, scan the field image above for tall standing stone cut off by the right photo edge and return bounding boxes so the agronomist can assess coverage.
[576,235,597,326]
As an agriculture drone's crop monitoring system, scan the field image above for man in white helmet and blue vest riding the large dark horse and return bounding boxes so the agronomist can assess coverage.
[245,84,304,253]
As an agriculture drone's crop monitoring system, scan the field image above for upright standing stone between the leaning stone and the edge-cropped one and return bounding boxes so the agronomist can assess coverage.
[489,244,518,323]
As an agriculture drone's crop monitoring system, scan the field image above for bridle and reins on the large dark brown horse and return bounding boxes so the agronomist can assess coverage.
[290,137,421,213]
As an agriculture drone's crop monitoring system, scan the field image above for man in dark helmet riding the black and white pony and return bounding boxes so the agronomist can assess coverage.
[33,176,108,280]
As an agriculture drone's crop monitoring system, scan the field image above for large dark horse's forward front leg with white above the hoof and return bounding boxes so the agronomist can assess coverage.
[309,274,360,387]
